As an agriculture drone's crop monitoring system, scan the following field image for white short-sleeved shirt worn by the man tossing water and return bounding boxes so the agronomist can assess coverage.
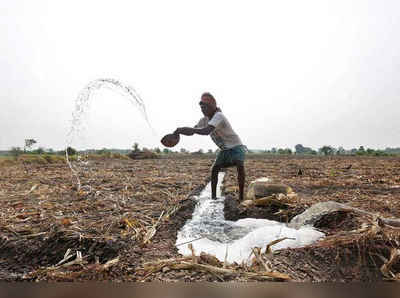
[195,112,242,150]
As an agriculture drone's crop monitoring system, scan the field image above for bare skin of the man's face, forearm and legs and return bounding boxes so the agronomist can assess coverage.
[174,102,245,201]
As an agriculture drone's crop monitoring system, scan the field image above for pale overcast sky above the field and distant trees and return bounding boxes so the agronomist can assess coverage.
[0,0,400,150]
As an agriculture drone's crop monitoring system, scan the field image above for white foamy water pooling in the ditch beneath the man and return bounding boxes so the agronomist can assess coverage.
[176,173,324,263]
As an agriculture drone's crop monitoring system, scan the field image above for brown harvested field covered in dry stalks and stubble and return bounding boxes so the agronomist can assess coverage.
[0,156,400,282]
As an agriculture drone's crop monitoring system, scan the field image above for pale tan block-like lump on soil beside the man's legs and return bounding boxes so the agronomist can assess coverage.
[247,177,293,200]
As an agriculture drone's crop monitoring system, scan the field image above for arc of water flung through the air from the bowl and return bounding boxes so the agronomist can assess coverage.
[65,78,155,190]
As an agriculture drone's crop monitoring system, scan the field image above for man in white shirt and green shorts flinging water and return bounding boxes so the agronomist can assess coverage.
[174,92,246,201]
